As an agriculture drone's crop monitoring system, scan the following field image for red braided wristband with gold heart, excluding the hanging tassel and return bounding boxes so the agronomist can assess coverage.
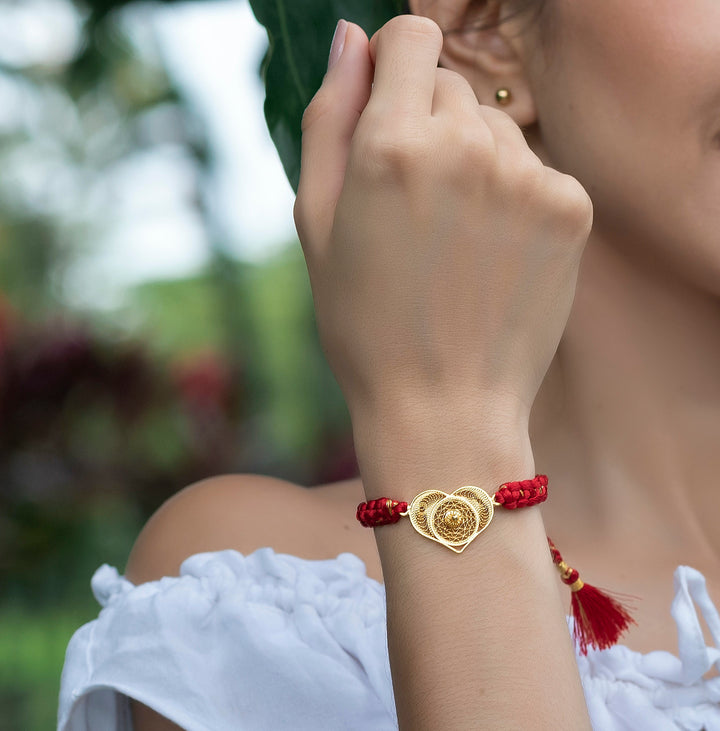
[356,475,548,553]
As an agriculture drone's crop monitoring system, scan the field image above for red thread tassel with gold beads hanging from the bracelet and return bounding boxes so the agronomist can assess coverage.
[548,537,637,655]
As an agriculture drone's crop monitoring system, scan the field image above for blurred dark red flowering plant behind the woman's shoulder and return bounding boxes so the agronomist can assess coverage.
[0,308,242,594]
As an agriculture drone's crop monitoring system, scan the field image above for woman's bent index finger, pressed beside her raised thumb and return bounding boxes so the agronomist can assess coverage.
[370,15,443,115]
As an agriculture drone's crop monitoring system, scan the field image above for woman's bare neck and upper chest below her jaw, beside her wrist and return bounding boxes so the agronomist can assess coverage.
[530,234,720,569]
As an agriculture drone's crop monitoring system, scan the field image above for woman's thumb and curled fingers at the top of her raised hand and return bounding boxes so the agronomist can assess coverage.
[294,15,539,253]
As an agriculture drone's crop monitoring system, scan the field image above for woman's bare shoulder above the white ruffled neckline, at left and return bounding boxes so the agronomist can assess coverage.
[124,474,381,585]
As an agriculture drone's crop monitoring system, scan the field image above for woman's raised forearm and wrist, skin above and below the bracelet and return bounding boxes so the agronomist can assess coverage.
[355,418,590,731]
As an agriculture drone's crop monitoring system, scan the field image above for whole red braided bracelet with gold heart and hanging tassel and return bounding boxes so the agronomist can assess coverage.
[356,475,637,655]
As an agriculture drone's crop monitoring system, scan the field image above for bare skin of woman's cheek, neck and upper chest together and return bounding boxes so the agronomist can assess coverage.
[527,0,720,651]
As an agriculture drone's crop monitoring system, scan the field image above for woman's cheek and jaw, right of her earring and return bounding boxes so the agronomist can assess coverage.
[527,0,720,295]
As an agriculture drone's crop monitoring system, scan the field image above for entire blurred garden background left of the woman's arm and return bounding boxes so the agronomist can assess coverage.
[0,0,357,731]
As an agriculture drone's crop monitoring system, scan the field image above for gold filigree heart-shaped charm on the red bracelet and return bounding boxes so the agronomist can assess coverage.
[408,485,493,553]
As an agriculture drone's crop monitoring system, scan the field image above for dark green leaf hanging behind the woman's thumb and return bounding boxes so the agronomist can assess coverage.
[250,0,403,191]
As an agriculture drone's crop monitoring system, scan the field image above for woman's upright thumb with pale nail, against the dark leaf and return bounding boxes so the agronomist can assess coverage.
[294,20,373,247]
